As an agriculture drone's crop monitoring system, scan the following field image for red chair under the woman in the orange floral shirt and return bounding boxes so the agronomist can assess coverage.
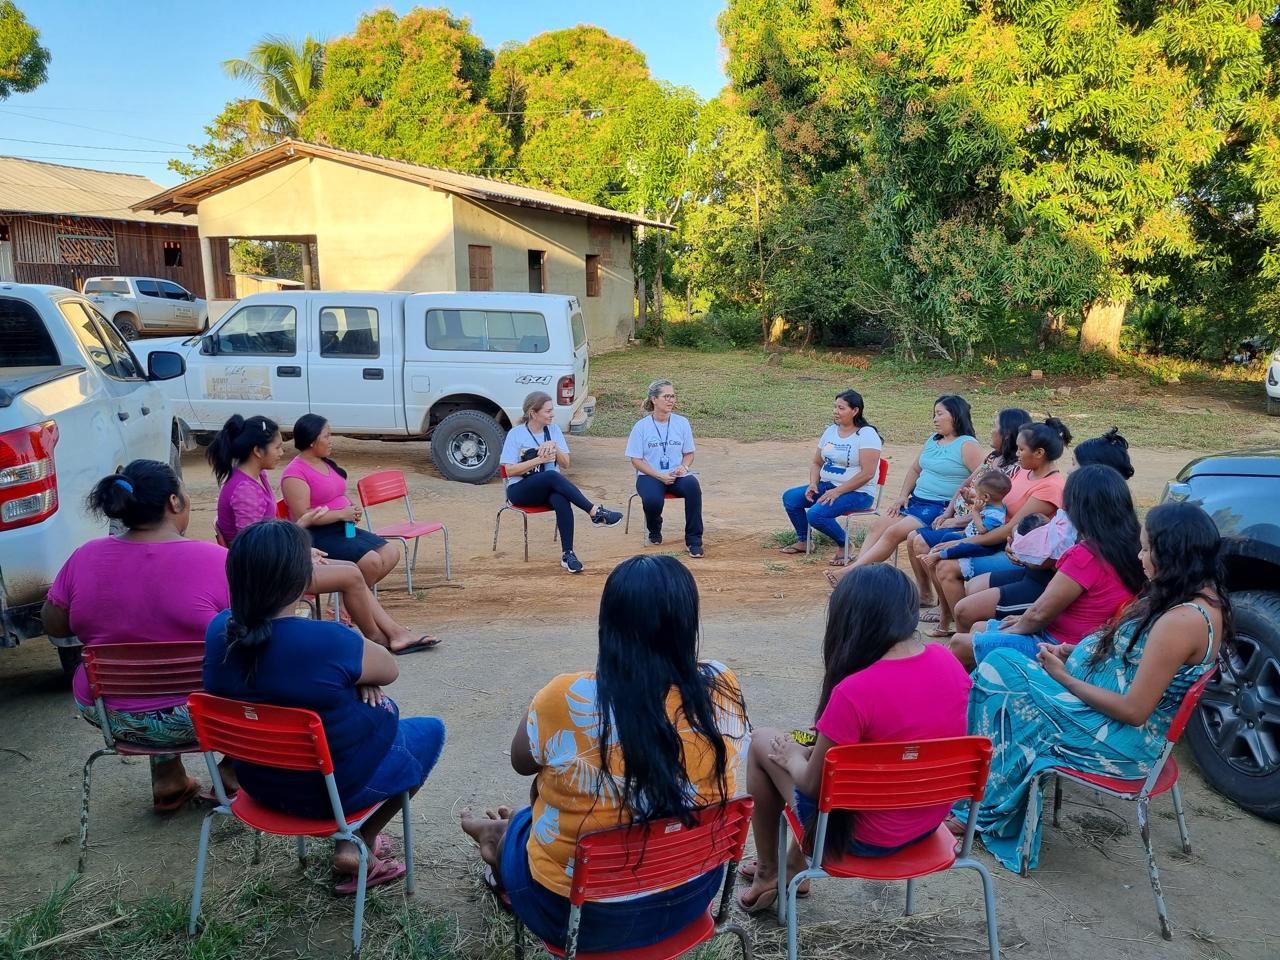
[512,796,755,960]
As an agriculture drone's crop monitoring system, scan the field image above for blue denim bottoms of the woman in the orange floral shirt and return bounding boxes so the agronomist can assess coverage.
[500,806,724,952]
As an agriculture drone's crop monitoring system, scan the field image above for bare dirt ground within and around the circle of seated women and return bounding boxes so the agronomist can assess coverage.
[0,438,1280,960]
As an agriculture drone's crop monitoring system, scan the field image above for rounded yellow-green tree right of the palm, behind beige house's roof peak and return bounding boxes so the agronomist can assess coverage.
[302,8,511,173]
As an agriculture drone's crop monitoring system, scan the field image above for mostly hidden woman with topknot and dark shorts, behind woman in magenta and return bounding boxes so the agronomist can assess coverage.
[955,426,1134,632]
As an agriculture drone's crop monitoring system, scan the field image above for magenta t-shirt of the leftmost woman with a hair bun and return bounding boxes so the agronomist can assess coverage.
[49,536,230,713]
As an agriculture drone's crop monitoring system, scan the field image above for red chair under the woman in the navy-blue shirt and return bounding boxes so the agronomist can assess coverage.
[187,694,413,956]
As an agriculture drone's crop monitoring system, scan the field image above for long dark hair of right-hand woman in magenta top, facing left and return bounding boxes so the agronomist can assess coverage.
[1062,463,1147,594]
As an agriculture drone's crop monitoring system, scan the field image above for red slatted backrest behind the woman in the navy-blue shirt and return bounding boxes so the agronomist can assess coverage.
[187,694,333,774]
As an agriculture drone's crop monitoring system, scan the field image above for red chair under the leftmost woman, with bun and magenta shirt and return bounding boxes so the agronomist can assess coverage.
[76,640,205,873]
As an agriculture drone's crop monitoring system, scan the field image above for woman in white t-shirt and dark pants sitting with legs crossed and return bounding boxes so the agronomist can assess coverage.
[500,390,622,573]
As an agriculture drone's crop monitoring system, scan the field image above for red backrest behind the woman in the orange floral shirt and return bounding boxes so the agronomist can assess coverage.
[568,796,754,905]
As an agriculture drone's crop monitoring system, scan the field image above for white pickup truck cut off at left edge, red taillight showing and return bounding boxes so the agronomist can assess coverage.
[0,283,183,667]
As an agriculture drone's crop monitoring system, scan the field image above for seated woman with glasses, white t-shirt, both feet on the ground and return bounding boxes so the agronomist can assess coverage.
[627,380,703,558]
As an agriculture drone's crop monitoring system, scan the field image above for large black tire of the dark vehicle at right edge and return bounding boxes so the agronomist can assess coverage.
[1187,590,1280,822]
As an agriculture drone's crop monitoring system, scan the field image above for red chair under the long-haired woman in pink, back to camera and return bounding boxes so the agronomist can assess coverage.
[778,737,1000,960]
